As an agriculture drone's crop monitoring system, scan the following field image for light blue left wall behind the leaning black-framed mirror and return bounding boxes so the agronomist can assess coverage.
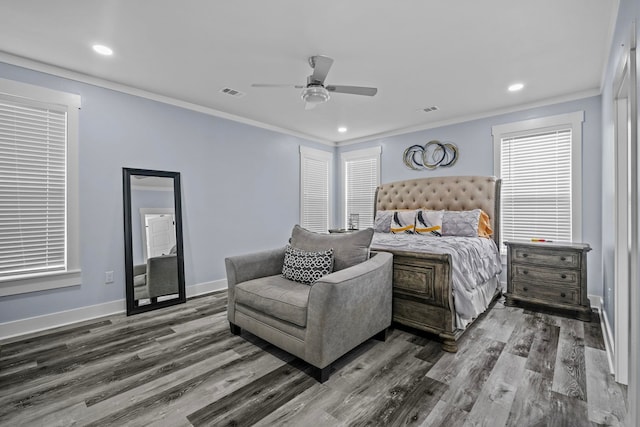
[0,63,334,323]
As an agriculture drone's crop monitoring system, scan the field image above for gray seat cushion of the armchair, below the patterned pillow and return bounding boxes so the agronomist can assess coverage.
[235,274,311,327]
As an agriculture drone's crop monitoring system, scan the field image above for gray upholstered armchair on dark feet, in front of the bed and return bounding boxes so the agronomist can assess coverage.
[225,226,393,382]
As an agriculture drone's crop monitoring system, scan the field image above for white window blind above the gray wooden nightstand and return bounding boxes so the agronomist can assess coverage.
[500,128,573,246]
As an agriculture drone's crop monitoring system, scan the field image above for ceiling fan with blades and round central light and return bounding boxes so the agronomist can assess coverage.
[251,55,378,110]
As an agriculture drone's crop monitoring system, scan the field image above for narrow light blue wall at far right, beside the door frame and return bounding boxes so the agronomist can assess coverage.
[601,0,640,332]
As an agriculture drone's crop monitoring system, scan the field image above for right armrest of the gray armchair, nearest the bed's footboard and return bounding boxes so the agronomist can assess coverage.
[305,252,393,368]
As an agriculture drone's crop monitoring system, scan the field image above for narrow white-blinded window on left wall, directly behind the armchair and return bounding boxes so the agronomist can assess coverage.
[300,146,333,233]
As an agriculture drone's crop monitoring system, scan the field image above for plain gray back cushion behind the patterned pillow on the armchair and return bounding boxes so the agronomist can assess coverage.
[290,225,373,271]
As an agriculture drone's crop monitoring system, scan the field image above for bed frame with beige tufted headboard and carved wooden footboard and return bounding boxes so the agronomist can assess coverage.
[375,176,501,353]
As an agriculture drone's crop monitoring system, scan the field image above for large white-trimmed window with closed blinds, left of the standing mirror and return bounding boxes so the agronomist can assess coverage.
[0,79,80,296]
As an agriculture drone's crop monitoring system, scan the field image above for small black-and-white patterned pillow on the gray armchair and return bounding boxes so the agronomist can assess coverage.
[282,245,333,285]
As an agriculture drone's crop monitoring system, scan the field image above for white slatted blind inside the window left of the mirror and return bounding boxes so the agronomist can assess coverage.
[0,99,67,277]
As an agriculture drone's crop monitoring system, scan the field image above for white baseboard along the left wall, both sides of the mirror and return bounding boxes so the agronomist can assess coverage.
[0,279,227,341]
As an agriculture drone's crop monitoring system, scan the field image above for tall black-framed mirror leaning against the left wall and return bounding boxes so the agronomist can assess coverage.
[123,168,186,314]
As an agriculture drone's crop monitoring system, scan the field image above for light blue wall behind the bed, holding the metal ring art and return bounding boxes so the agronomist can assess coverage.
[338,96,602,295]
